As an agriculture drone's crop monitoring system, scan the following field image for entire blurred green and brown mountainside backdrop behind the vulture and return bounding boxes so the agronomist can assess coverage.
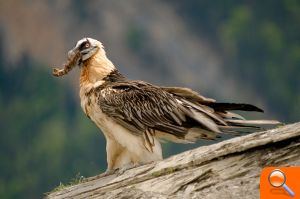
[0,0,300,198]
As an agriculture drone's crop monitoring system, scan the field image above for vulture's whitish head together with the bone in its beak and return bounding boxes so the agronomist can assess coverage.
[53,37,113,76]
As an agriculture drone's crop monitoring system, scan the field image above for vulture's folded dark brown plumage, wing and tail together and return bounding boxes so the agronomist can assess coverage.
[95,81,278,148]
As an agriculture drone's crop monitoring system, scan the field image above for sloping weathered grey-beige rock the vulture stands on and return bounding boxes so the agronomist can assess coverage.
[48,123,300,199]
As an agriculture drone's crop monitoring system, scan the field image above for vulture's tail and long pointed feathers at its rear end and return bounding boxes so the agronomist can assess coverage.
[162,87,282,142]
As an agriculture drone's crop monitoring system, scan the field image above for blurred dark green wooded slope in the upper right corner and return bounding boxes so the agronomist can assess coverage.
[174,0,300,122]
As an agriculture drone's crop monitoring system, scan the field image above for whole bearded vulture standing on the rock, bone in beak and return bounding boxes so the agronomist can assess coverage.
[53,37,280,172]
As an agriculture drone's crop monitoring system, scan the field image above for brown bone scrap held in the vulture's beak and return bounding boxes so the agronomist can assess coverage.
[52,50,80,77]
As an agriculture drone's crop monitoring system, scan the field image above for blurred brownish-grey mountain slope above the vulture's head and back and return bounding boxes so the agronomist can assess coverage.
[0,0,259,101]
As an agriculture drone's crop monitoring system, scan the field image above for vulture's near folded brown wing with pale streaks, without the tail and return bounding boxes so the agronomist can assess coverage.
[99,81,219,139]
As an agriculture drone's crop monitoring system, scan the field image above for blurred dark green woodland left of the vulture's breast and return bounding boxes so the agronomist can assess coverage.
[0,35,106,198]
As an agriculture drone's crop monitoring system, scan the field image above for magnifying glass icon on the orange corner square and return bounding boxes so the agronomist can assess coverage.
[269,169,295,197]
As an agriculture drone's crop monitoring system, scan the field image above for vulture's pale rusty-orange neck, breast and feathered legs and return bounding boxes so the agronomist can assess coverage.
[80,52,162,170]
